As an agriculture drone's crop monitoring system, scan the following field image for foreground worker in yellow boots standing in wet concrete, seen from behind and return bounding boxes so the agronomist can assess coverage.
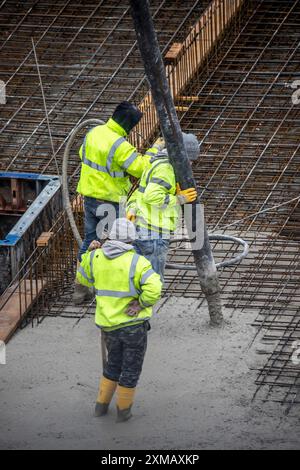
[77,218,162,422]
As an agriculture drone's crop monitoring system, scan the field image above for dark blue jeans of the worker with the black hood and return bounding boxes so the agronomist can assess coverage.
[78,196,119,261]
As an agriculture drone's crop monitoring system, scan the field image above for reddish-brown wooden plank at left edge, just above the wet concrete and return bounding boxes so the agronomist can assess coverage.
[0,280,43,343]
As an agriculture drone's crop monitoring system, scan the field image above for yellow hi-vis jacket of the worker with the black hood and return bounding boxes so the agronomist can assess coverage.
[77,119,157,202]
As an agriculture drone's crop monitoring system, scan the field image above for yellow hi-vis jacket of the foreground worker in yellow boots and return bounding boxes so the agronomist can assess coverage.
[76,249,162,331]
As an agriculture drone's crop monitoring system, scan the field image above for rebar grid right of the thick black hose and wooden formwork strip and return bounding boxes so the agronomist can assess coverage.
[166,0,300,410]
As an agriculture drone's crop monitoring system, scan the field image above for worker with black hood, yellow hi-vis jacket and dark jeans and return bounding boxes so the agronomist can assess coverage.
[73,101,157,304]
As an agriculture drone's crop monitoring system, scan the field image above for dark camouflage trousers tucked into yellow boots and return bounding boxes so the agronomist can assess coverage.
[103,321,149,388]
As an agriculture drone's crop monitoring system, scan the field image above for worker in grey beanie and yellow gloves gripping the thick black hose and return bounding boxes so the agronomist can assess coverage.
[126,133,199,281]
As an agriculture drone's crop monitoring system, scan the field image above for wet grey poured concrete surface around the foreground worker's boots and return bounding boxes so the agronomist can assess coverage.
[0,299,300,450]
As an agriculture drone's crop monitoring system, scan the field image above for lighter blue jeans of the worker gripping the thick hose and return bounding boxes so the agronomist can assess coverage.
[134,238,170,282]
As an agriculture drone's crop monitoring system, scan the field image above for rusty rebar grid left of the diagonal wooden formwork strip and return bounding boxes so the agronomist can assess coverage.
[0,0,208,173]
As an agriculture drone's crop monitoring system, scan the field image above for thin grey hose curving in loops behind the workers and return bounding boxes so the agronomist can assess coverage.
[62,123,249,271]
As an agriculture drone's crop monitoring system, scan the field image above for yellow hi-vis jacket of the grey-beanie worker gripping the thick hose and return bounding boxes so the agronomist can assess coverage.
[127,155,180,238]
